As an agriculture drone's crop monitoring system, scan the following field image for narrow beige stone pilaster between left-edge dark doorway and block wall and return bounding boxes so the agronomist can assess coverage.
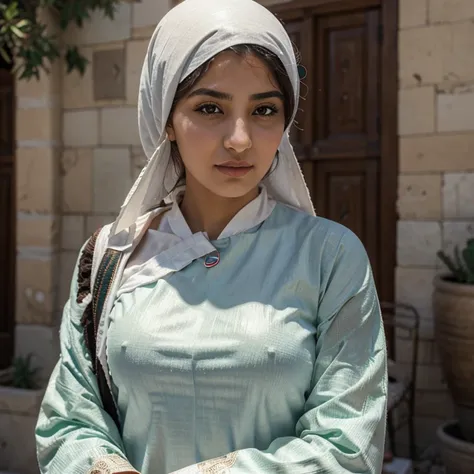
[15,9,61,376]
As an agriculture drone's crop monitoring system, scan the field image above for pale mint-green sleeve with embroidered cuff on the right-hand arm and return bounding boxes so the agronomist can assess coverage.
[175,231,387,474]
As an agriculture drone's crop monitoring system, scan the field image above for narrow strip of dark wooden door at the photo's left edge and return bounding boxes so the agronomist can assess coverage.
[0,68,16,369]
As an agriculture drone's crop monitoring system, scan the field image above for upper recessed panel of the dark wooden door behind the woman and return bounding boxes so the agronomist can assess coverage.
[312,10,380,159]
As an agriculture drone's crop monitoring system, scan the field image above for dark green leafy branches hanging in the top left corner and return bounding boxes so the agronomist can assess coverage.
[0,0,120,80]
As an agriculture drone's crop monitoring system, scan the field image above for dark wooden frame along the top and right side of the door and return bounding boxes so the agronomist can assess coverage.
[268,0,398,308]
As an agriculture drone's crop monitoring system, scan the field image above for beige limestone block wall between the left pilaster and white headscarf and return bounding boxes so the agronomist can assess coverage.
[57,0,171,311]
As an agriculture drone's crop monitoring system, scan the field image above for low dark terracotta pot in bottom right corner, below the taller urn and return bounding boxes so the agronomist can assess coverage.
[436,421,474,474]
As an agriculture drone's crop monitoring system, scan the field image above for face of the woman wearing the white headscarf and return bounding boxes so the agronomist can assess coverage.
[167,51,285,198]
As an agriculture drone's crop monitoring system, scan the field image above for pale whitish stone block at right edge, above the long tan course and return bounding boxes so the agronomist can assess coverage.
[437,89,474,132]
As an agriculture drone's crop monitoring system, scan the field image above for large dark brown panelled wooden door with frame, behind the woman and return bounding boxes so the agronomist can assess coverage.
[273,0,398,301]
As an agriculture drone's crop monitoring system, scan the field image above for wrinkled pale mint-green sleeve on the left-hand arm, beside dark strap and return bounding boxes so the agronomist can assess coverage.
[36,250,136,474]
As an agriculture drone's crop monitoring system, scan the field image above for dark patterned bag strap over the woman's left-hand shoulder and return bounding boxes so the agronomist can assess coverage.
[77,229,122,427]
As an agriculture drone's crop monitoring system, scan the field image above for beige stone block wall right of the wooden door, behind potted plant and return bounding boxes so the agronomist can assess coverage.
[396,0,474,458]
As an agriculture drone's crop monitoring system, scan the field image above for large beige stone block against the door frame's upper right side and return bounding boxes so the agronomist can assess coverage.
[398,24,452,87]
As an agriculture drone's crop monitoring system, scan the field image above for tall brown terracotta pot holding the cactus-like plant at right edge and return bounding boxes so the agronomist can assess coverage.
[433,275,474,441]
